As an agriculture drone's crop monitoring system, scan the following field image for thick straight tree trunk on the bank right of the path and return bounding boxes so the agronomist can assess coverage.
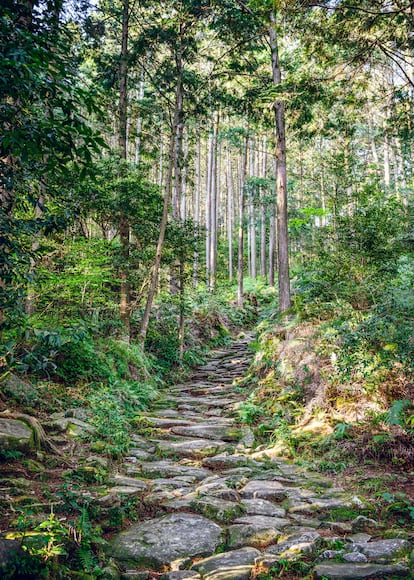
[269,11,291,312]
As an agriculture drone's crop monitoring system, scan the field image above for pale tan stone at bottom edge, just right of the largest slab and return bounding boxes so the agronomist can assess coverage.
[192,548,260,580]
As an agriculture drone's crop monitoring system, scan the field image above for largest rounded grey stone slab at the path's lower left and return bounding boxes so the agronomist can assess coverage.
[110,513,222,570]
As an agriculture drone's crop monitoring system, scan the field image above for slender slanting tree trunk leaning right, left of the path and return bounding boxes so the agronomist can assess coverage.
[138,49,183,344]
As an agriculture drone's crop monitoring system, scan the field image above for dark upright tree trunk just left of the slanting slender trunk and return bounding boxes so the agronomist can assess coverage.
[118,0,131,342]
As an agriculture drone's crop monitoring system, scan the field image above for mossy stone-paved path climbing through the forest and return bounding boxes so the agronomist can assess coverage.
[107,337,414,580]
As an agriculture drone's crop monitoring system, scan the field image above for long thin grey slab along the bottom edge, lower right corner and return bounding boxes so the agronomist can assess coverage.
[314,563,411,580]
